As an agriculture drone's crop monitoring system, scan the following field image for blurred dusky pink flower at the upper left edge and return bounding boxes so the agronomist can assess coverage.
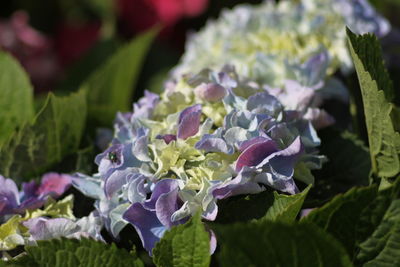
[0,11,60,90]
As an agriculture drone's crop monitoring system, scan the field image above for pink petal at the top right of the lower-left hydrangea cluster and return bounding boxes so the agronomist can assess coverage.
[37,173,72,198]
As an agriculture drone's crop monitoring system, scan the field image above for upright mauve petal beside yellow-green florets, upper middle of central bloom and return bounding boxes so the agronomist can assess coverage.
[177,104,201,139]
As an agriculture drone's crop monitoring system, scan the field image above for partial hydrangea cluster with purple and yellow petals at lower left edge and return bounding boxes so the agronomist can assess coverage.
[0,173,102,250]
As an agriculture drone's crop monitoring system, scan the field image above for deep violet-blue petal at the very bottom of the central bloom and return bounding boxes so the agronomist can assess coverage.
[122,203,167,254]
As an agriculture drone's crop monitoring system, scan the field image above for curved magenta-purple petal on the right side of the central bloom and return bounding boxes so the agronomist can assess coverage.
[236,140,278,172]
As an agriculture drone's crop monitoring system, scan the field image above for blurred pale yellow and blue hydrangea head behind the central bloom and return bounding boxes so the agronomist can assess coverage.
[173,0,390,86]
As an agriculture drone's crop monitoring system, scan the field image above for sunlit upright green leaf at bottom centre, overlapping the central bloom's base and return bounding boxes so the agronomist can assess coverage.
[153,213,210,267]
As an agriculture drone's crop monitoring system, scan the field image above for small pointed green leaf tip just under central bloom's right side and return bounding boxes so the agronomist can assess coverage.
[261,185,311,223]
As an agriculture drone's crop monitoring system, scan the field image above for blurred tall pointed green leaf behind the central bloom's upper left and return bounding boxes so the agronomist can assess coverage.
[83,30,156,126]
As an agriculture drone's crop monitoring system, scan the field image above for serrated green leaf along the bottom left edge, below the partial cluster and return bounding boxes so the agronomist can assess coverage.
[4,238,144,267]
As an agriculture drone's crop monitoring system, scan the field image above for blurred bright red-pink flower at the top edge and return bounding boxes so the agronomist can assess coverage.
[117,0,208,32]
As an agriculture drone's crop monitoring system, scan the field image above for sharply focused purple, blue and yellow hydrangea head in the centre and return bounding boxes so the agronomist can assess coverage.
[72,67,324,253]
